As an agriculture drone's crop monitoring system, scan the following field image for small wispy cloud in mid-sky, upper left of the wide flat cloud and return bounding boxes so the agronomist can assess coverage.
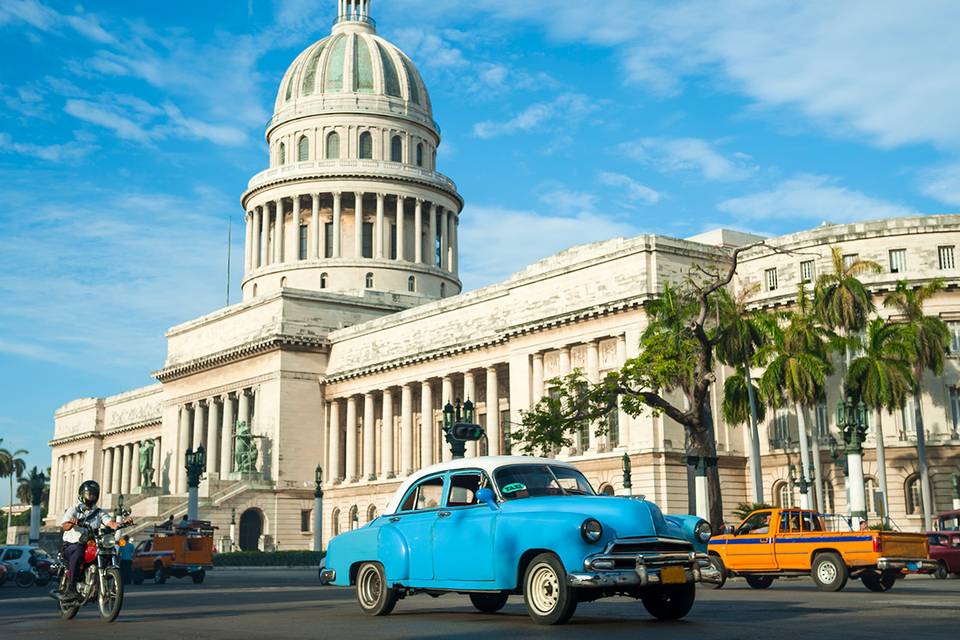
[618,138,756,180]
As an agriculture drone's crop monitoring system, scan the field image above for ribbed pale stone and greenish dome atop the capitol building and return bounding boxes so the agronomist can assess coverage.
[270,4,437,130]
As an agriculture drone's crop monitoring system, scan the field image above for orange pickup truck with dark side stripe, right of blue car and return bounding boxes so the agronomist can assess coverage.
[708,509,937,591]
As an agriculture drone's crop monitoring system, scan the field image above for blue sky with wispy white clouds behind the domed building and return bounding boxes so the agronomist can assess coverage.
[0,0,960,499]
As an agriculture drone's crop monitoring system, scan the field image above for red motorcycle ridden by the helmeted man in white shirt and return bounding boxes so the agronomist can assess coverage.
[55,511,130,622]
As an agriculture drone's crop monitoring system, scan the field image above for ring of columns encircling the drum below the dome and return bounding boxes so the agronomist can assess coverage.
[244,191,459,274]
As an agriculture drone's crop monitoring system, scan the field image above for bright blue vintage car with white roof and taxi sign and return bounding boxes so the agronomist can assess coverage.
[321,456,713,624]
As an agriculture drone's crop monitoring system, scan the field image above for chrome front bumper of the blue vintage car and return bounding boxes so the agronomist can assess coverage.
[567,551,720,587]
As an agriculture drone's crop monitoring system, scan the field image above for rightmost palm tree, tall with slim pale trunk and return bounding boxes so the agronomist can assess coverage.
[883,279,950,531]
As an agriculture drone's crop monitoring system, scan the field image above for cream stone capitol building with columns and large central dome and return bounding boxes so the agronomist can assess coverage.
[50,0,960,549]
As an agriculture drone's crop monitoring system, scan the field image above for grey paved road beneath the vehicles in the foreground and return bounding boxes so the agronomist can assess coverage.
[0,570,960,640]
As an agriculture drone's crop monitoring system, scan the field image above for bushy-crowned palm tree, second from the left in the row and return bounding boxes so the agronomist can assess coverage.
[757,285,832,508]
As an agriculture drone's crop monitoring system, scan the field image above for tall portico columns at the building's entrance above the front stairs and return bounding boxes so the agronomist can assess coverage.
[173,387,260,493]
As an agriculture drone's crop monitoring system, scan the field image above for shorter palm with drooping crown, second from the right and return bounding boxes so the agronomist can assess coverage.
[846,318,914,520]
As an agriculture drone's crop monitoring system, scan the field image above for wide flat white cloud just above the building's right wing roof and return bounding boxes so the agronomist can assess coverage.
[717,175,917,225]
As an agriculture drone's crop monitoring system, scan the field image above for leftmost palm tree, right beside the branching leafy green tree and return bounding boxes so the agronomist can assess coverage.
[716,285,776,502]
